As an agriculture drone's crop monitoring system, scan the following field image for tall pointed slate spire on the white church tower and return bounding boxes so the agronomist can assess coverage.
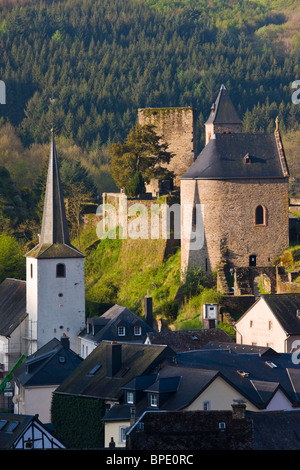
[26,130,84,258]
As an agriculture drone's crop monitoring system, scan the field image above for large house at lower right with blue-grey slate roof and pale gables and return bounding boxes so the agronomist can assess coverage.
[104,342,300,446]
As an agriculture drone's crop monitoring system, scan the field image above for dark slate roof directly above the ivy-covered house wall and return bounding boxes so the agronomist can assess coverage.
[54,341,174,400]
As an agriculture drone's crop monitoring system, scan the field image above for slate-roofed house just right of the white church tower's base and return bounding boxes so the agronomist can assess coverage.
[79,304,154,358]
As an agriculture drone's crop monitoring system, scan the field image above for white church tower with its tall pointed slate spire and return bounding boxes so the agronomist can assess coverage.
[26,130,85,354]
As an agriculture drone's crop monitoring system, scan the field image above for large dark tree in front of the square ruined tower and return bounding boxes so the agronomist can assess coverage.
[109,124,174,194]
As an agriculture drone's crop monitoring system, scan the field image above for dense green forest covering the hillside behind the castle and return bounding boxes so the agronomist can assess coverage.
[0,0,300,302]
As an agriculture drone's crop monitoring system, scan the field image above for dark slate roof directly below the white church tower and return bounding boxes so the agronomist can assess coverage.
[13,338,83,387]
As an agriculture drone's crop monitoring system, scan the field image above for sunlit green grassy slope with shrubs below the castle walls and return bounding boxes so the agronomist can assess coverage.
[80,217,236,333]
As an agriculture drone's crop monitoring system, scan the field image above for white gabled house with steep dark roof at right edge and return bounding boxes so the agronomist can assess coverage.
[235,293,300,353]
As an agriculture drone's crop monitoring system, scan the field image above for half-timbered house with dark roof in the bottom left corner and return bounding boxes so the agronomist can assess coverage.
[0,413,65,450]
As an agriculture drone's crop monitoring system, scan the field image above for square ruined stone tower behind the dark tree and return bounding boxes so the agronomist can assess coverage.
[138,107,197,185]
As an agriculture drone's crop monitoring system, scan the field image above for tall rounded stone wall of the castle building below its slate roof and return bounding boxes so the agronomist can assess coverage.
[181,179,289,271]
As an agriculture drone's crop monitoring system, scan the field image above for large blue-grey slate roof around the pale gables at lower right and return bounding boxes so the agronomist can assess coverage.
[104,343,300,421]
